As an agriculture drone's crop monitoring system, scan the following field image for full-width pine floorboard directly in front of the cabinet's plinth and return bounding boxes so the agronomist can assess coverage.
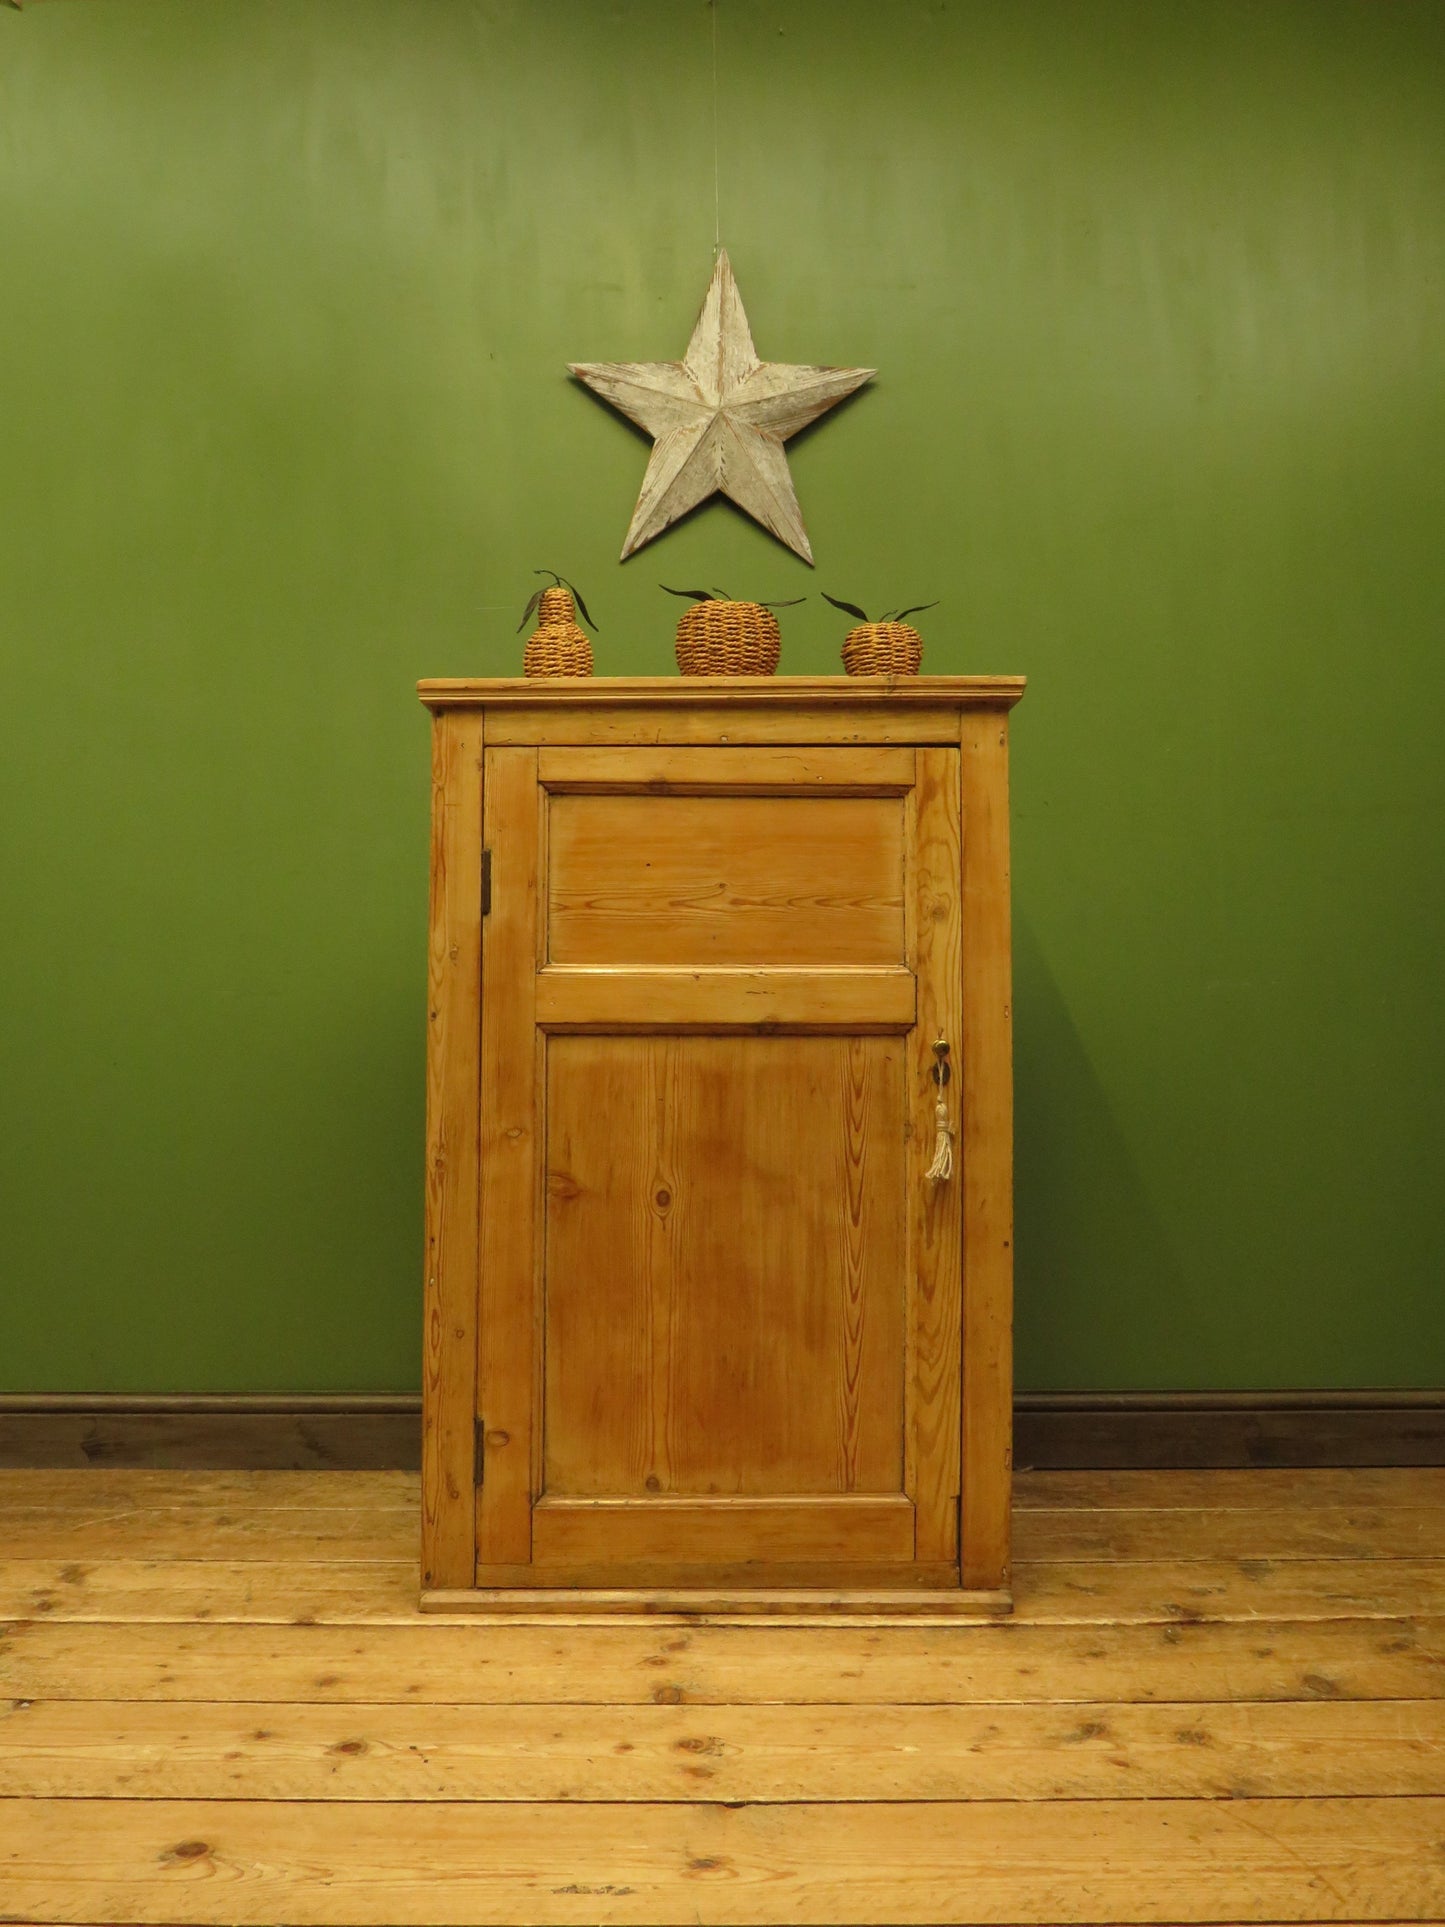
[0,1618,1445,1709]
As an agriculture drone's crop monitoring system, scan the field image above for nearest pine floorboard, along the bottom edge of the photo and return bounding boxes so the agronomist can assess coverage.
[0,1798,1445,1927]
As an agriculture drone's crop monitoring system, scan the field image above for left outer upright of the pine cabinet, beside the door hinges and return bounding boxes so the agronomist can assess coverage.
[422,709,482,1588]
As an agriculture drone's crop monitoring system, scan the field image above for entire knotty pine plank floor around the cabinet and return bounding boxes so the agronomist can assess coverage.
[0,1468,1445,1927]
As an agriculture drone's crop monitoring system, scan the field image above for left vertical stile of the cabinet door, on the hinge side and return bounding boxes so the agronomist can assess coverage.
[476,748,541,1567]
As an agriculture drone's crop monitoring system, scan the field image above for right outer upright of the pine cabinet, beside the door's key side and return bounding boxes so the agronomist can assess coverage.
[959,709,1013,1588]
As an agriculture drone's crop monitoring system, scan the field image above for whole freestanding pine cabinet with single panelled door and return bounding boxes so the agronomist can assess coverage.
[422,676,1023,1613]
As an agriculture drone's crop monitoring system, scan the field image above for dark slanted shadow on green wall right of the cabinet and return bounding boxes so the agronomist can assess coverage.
[1013,910,1196,1391]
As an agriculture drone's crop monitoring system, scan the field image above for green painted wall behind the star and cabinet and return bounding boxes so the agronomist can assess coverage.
[0,0,1445,1391]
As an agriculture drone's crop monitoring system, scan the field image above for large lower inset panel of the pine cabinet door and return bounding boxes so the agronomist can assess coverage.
[545,1037,904,1503]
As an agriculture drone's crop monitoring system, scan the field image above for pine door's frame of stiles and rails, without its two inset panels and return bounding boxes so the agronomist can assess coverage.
[476,746,961,1586]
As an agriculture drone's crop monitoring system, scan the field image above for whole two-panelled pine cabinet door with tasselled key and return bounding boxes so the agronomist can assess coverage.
[478,746,961,1586]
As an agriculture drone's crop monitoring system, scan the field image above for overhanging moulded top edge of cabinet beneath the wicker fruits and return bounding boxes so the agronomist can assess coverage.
[416,676,1025,709]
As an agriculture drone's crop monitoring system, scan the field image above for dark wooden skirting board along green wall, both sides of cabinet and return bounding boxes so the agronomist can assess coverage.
[0,1391,1445,1472]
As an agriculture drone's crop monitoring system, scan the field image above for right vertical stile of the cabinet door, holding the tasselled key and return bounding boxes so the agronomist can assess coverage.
[907,750,965,1559]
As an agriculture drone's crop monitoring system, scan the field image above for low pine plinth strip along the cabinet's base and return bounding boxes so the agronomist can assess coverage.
[420,1586,1013,1619]
